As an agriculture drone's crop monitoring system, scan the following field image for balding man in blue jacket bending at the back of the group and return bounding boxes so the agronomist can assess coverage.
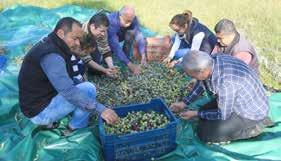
[108,6,146,74]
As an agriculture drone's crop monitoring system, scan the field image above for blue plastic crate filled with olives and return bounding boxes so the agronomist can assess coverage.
[99,98,178,161]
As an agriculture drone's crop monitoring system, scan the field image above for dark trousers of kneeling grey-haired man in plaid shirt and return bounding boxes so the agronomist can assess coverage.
[197,99,263,142]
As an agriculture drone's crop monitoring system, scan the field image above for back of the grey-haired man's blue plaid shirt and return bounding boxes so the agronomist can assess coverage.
[213,55,269,120]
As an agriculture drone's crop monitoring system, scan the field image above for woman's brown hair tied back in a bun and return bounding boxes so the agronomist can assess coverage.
[169,10,192,27]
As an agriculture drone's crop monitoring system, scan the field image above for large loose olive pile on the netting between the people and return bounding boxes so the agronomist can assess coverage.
[91,63,188,106]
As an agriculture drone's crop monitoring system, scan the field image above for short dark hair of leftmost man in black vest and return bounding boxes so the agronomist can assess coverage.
[54,17,82,34]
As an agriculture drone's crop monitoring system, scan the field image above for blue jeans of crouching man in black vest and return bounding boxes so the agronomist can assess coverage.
[30,82,96,129]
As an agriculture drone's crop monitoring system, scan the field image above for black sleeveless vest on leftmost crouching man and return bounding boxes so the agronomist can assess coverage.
[18,33,79,118]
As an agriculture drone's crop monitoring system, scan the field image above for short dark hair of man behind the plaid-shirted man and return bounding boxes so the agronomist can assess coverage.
[215,19,237,34]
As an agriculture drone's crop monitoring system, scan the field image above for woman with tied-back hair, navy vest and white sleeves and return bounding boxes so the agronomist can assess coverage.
[163,10,217,68]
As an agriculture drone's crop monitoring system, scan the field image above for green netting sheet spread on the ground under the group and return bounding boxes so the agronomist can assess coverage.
[0,5,281,161]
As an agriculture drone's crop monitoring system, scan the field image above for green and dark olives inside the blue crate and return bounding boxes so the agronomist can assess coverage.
[104,111,169,135]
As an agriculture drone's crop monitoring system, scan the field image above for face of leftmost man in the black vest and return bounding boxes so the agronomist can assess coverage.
[58,24,83,53]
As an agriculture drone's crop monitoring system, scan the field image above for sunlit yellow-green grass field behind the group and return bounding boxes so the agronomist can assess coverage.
[0,0,281,89]
